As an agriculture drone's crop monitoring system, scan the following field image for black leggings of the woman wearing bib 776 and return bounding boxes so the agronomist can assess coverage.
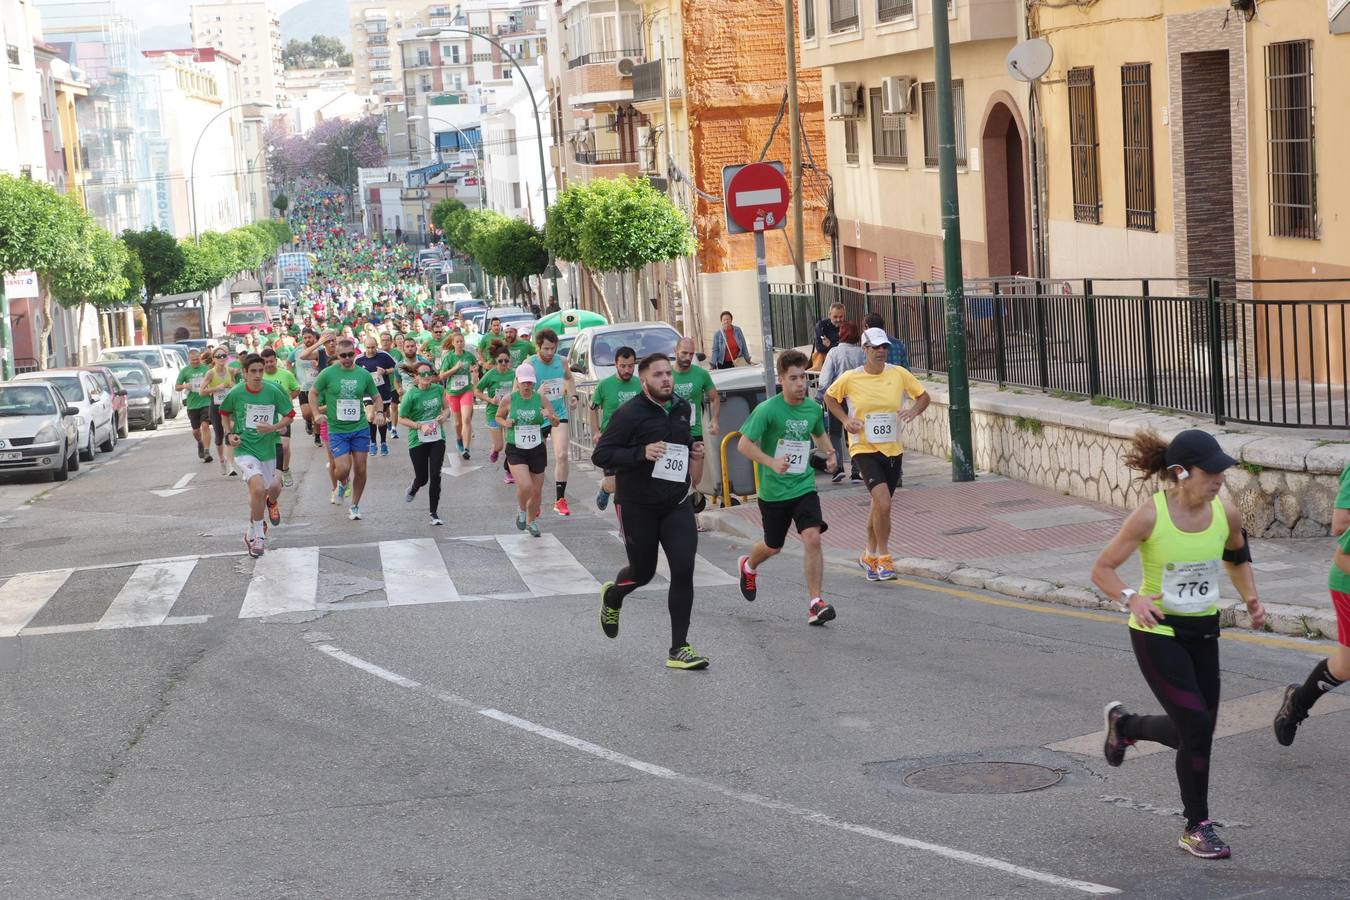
[1121,617,1219,827]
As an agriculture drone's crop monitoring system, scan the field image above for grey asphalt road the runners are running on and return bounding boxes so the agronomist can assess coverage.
[0,413,1350,899]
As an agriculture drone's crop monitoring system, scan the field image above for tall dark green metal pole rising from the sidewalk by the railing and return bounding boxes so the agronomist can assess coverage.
[933,0,975,482]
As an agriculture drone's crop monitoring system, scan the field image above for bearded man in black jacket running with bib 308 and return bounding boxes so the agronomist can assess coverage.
[591,354,707,669]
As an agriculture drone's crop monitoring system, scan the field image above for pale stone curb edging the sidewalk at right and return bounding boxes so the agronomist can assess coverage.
[698,510,1337,641]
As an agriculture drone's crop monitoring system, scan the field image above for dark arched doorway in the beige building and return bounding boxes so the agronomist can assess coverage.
[981,97,1031,275]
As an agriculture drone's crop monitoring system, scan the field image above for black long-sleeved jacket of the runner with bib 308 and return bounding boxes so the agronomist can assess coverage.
[591,393,694,506]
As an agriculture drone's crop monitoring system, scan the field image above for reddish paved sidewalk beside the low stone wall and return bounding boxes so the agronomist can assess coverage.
[701,451,1337,638]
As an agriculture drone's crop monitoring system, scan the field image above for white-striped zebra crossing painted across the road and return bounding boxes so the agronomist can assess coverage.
[0,532,736,638]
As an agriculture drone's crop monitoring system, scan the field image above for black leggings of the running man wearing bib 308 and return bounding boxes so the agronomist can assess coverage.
[605,501,698,650]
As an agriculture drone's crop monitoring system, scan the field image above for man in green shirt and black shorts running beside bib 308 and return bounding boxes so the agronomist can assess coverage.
[736,349,834,625]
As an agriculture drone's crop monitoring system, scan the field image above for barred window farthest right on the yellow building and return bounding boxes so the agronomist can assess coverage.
[1266,40,1318,239]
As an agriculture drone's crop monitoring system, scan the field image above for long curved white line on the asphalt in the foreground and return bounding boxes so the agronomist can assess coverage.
[313,644,1121,895]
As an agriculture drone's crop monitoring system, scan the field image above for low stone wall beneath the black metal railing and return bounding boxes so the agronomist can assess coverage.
[905,382,1350,537]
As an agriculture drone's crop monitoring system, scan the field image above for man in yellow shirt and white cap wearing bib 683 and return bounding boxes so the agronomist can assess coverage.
[825,328,930,582]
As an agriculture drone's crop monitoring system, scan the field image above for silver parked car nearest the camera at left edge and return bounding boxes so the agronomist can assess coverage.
[0,379,80,482]
